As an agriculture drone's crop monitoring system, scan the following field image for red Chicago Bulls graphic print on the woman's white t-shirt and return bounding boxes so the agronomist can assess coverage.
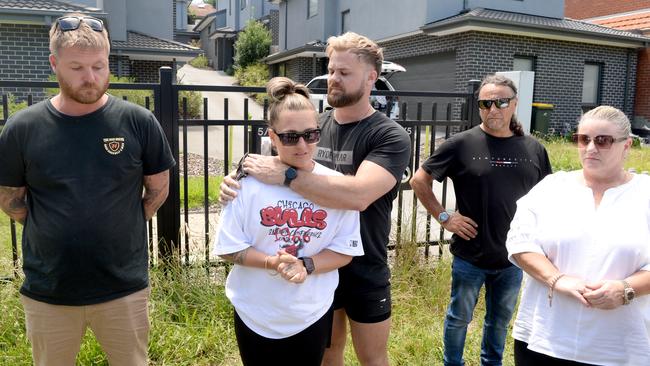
[260,200,327,257]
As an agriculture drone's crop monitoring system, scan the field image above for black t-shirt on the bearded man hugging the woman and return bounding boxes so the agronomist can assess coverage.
[314,111,411,291]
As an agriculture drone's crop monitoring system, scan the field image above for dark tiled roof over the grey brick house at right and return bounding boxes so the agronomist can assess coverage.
[421,8,650,48]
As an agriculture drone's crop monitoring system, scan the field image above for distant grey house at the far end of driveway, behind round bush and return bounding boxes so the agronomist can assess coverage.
[194,0,278,70]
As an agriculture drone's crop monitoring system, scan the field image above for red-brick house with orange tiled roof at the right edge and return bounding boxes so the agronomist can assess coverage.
[564,0,650,128]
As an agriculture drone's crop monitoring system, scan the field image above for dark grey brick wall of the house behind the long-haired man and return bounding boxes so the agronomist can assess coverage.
[381,32,636,132]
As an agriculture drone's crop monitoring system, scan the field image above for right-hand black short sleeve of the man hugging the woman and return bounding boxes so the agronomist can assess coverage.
[364,121,411,182]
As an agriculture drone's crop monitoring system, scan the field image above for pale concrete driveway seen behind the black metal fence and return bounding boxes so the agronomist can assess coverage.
[177,64,264,162]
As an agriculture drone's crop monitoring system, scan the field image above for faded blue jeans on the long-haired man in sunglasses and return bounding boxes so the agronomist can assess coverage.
[443,256,522,366]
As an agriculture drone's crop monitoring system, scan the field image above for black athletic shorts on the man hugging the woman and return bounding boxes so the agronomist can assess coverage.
[333,285,392,323]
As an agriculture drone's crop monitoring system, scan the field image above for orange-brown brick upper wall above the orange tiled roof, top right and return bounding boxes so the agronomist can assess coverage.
[564,0,650,19]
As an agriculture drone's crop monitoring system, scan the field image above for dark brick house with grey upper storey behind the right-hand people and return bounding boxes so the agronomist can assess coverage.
[266,0,650,133]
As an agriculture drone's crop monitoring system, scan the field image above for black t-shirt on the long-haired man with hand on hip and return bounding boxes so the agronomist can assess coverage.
[422,126,551,269]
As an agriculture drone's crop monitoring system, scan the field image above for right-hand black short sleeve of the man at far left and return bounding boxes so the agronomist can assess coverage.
[142,112,176,175]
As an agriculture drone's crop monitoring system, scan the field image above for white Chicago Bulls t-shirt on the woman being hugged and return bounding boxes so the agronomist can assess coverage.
[214,164,363,339]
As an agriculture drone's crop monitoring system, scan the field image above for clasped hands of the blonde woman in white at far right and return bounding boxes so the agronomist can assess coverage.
[555,276,624,310]
